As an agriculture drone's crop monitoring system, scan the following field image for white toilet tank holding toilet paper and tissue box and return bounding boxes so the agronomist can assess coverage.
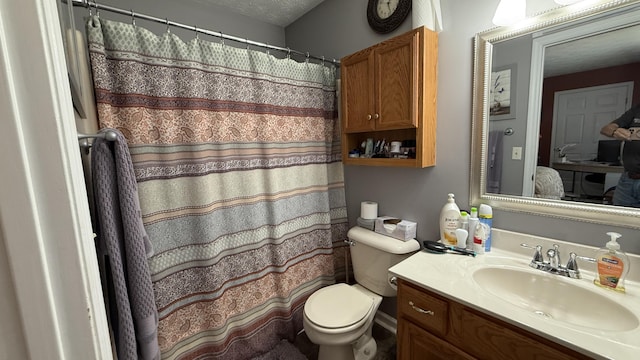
[347,226,420,297]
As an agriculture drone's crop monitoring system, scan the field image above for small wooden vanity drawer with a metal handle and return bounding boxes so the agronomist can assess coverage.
[398,280,449,335]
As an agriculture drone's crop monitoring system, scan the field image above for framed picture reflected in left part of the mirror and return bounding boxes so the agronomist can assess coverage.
[489,64,517,120]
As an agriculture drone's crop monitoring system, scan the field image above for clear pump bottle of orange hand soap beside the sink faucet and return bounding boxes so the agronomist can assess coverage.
[593,232,629,292]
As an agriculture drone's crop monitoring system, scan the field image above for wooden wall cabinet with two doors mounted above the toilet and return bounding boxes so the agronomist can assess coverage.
[340,27,438,168]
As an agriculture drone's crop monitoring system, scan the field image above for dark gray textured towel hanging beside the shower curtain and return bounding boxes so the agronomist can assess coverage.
[91,130,160,360]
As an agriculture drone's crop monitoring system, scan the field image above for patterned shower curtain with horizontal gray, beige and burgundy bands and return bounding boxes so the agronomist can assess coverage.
[87,17,348,359]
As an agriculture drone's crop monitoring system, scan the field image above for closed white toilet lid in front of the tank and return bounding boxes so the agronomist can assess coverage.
[304,284,373,329]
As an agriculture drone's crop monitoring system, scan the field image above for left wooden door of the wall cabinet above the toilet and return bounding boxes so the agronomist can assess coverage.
[340,49,375,133]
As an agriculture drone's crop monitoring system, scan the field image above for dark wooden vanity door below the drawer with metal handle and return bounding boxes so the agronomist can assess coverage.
[398,319,474,360]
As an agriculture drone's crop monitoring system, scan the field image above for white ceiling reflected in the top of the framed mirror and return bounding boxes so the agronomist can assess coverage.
[544,25,640,77]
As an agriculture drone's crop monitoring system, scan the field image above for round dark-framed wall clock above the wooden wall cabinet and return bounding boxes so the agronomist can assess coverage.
[367,0,411,34]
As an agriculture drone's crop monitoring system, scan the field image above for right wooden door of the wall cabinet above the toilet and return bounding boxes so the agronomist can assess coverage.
[375,31,420,130]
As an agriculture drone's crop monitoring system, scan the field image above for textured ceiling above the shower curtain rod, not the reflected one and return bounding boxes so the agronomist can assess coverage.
[191,0,324,27]
